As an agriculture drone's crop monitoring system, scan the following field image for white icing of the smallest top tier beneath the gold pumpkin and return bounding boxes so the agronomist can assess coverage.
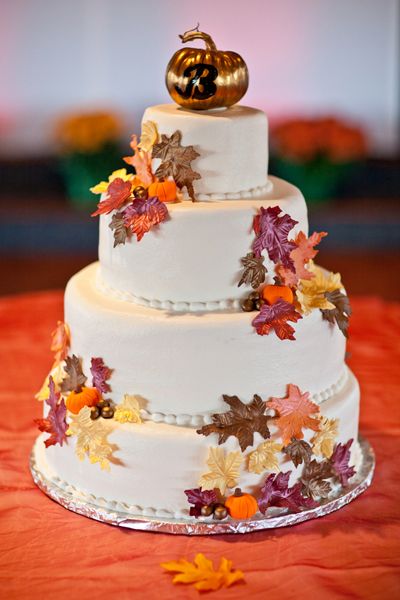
[142,104,268,201]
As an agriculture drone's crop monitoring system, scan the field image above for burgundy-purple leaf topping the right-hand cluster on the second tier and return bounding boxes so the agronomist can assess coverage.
[253,206,298,271]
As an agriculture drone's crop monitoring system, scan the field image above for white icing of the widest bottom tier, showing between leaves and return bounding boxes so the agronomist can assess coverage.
[38,373,361,516]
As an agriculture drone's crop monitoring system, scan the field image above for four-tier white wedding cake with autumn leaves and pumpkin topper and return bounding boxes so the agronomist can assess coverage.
[35,31,362,523]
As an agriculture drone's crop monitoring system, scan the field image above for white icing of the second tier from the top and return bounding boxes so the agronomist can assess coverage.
[99,178,308,302]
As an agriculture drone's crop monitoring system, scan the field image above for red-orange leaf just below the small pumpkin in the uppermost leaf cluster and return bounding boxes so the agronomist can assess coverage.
[123,196,169,242]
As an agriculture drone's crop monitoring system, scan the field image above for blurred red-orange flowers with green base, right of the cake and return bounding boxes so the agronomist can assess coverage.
[271,118,366,203]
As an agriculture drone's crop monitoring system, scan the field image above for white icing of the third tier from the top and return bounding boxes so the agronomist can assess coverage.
[65,263,346,425]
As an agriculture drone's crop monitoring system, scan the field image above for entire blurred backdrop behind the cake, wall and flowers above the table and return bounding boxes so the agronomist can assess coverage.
[0,0,400,299]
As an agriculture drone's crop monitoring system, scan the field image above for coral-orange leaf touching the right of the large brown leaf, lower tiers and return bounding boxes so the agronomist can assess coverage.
[267,383,320,445]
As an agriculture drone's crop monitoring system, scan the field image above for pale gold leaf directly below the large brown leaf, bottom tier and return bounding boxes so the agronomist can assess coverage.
[198,448,243,494]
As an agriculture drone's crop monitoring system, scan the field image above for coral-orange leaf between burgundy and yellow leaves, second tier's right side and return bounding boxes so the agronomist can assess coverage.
[276,231,328,286]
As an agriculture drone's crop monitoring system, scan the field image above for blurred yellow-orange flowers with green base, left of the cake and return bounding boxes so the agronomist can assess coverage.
[56,112,121,210]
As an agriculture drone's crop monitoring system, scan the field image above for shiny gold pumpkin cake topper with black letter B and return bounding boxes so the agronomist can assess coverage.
[165,26,249,110]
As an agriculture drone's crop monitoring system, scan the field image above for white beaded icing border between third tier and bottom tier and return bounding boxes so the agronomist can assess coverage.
[140,367,349,427]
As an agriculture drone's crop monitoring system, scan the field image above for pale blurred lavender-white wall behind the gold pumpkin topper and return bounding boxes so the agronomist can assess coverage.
[0,0,400,154]
